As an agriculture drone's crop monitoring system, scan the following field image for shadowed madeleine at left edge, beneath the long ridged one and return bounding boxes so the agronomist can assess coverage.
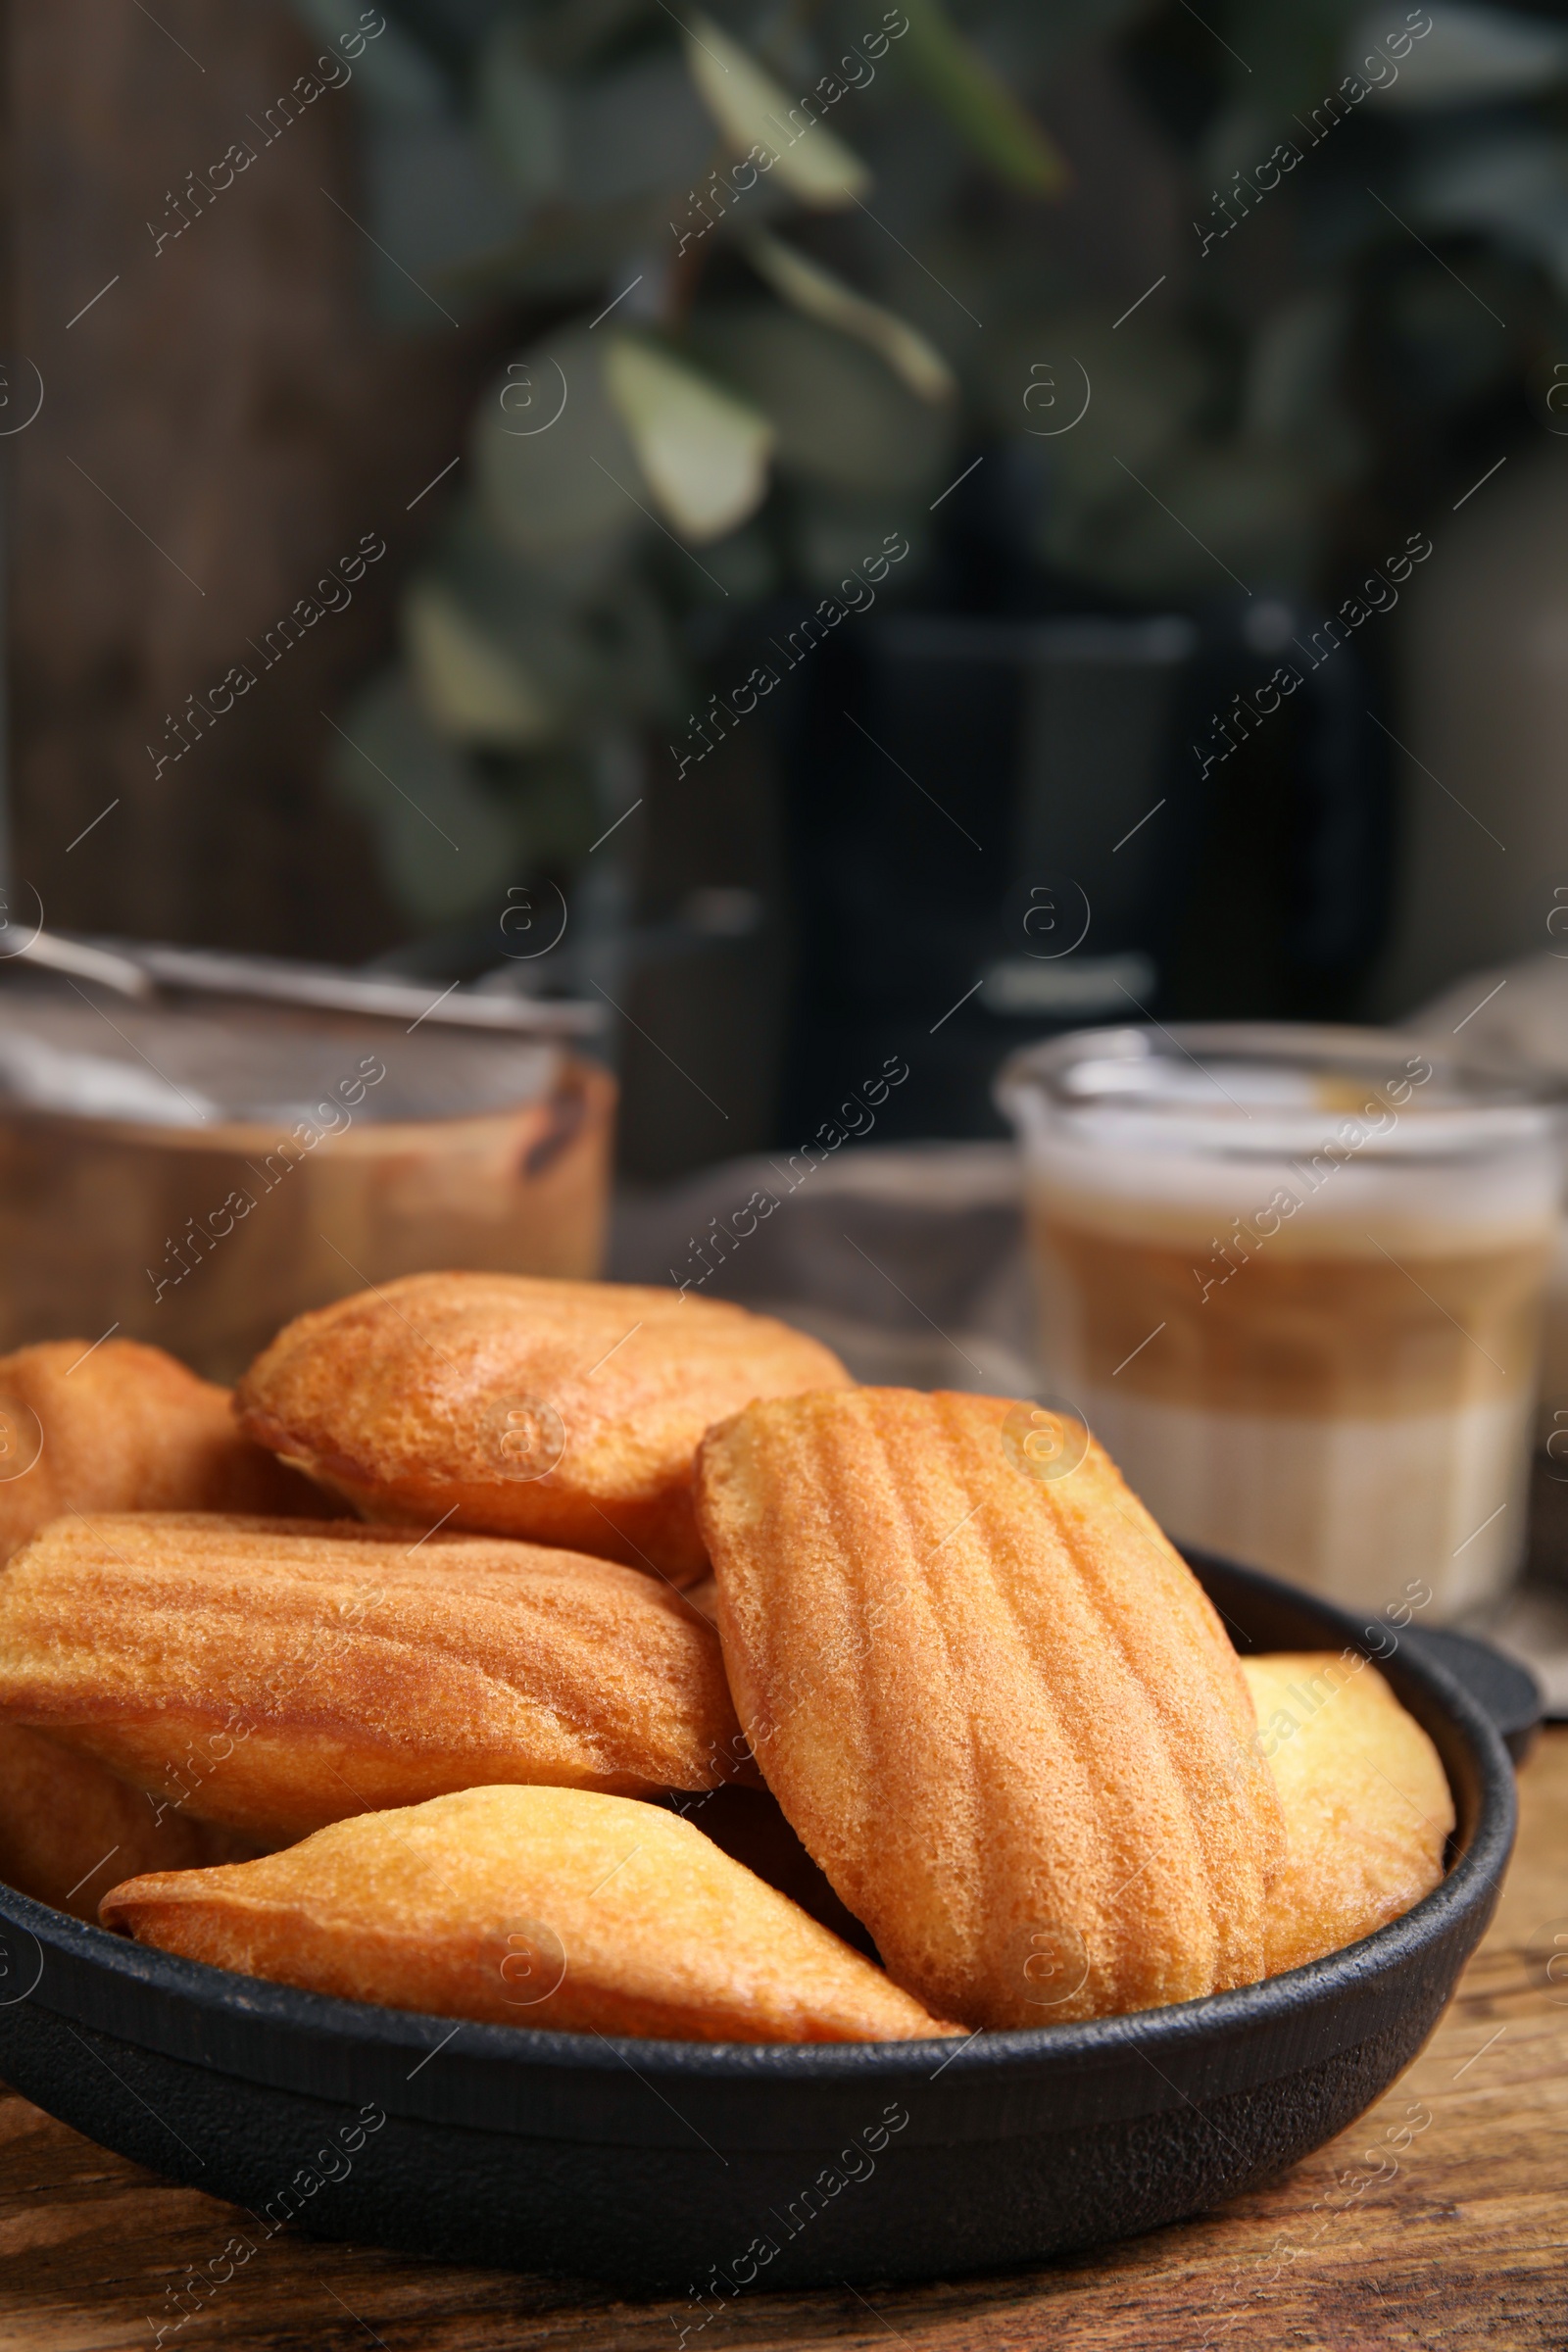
[0,1722,256,1919]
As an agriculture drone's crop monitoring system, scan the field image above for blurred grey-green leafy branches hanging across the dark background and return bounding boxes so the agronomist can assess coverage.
[296,0,1568,919]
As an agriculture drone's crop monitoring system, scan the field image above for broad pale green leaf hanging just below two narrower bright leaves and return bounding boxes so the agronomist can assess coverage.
[604,334,773,543]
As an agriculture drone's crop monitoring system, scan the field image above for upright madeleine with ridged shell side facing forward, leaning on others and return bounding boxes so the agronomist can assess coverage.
[698,1388,1281,2025]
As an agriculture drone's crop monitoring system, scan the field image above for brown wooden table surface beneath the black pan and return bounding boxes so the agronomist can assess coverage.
[0,1729,1568,2352]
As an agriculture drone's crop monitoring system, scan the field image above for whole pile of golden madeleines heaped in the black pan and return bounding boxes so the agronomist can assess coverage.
[0,1275,1452,2041]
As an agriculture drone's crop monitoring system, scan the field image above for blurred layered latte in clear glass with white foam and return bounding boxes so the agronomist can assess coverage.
[997,1023,1563,1623]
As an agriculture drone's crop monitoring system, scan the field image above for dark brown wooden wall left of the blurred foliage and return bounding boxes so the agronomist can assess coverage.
[0,0,499,957]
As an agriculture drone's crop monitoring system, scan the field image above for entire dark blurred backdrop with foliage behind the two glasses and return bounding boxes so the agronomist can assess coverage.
[12,0,1568,1181]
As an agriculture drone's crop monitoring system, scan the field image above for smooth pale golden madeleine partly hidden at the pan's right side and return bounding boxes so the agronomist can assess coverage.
[1242,1651,1452,1976]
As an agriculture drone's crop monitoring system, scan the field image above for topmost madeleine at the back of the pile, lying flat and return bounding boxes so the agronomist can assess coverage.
[235,1275,849,1583]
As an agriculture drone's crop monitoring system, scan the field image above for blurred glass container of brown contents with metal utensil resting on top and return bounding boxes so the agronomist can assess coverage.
[0,971,615,1381]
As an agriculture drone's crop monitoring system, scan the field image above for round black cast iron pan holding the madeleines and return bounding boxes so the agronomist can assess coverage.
[0,1552,1514,2285]
